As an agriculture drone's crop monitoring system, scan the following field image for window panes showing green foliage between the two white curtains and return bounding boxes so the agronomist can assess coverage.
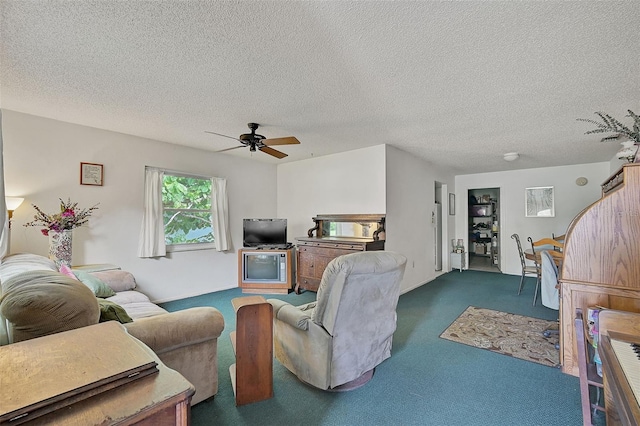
[162,172,214,251]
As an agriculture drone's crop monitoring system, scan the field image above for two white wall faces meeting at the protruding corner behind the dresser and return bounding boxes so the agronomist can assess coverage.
[278,145,454,292]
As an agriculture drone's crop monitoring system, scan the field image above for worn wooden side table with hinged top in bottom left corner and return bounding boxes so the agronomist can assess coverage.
[0,321,195,426]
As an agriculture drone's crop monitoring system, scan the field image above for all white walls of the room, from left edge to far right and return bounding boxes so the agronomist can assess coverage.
[2,110,620,301]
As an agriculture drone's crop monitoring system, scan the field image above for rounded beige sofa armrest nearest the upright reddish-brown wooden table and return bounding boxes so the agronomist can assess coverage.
[124,307,224,355]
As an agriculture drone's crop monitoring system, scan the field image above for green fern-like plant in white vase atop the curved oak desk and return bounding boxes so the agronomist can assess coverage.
[578,110,640,163]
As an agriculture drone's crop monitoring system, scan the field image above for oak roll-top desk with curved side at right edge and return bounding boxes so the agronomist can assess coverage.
[560,163,640,376]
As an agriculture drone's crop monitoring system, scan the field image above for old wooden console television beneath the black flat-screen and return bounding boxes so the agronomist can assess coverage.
[238,248,295,293]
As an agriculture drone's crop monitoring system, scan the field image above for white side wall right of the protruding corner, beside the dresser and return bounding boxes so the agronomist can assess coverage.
[385,146,455,293]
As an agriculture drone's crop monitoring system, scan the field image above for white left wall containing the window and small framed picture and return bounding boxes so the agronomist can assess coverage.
[2,110,277,301]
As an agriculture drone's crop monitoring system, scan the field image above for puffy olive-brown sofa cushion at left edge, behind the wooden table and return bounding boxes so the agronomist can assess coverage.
[0,271,100,342]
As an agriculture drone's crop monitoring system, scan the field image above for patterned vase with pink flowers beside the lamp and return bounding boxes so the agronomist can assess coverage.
[24,198,98,267]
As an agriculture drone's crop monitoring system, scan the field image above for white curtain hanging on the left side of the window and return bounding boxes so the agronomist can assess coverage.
[138,167,167,257]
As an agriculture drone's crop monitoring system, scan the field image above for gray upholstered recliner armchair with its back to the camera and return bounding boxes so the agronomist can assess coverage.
[268,251,406,390]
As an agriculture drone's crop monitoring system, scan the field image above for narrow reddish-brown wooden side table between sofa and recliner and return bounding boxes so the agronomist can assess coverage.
[229,296,273,406]
